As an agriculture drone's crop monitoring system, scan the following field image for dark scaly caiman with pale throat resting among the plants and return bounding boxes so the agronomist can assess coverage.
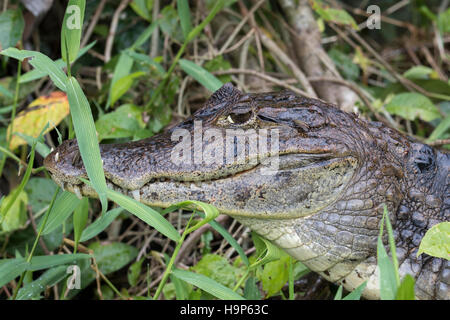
[44,84,450,300]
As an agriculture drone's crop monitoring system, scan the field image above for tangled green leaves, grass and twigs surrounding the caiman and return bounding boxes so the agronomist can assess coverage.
[0,0,450,300]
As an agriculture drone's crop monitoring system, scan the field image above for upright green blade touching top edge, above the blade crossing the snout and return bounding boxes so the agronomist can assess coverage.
[61,0,86,64]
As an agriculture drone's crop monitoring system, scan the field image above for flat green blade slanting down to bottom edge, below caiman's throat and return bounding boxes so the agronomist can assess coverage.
[172,270,245,300]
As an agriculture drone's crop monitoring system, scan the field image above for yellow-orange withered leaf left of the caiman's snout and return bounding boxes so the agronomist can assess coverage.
[8,91,69,150]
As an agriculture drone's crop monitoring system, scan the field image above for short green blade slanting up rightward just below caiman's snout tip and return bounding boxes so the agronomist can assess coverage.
[38,191,81,235]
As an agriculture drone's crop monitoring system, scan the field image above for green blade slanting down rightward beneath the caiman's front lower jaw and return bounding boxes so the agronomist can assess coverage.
[107,189,180,241]
